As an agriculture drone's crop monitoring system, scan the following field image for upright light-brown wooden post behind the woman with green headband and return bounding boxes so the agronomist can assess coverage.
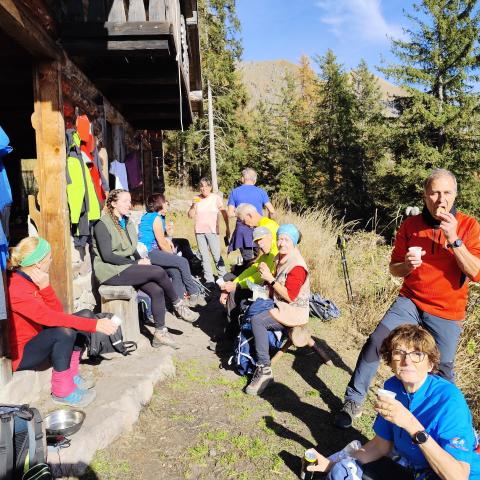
[32,61,73,312]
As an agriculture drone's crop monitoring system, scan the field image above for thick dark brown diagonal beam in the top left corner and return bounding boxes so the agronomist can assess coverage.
[0,0,61,59]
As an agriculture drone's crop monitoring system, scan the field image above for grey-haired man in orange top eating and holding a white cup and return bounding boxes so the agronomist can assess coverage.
[335,169,480,428]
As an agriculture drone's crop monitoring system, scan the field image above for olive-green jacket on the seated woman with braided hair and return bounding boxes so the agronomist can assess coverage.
[93,214,137,284]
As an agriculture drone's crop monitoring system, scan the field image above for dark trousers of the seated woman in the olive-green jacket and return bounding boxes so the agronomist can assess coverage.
[103,264,179,328]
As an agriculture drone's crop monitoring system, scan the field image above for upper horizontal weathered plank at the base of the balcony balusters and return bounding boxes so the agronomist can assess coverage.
[62,22,173,38]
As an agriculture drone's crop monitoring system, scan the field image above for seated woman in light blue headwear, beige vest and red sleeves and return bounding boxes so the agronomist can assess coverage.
[245,223,310,395]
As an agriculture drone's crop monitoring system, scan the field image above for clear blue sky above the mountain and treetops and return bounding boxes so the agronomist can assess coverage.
[237,0,413,76]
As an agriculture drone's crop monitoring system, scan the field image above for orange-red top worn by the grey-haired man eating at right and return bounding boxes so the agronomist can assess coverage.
[391,211,480,320]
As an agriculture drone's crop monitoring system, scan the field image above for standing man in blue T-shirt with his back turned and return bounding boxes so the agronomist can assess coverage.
[228,168,275,265]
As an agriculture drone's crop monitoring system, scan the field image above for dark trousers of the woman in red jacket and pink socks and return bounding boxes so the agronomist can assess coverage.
[17,310,96,372]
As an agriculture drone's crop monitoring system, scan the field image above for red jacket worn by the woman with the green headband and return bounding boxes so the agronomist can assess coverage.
[8,273,97,371]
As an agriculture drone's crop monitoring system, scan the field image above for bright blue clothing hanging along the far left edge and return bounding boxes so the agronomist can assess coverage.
[0,127,13,272]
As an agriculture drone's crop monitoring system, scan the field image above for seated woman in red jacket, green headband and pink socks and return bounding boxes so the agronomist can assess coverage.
[8,237,117,407]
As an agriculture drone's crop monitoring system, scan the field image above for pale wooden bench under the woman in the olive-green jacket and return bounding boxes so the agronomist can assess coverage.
[98,285,141,343]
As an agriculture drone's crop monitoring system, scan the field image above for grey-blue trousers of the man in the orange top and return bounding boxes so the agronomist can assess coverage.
[345,297,462,404]
